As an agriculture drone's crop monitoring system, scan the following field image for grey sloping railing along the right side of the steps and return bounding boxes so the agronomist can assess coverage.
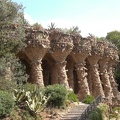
[77,95,102,120]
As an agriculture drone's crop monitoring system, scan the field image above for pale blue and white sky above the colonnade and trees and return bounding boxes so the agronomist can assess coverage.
[12,0,120,37]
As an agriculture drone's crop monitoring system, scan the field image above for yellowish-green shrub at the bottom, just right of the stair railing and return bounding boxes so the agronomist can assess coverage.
[89,103,108,120]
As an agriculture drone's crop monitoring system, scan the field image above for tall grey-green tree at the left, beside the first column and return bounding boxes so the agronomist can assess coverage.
[0,0,28,84]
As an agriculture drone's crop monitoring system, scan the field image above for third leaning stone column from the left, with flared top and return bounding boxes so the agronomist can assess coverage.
[71,34,91,100]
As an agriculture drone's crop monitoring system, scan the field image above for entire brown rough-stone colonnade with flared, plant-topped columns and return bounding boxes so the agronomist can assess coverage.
[19,28,118,100]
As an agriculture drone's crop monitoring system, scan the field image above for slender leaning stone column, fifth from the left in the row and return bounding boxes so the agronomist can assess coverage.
[99,41,113,100]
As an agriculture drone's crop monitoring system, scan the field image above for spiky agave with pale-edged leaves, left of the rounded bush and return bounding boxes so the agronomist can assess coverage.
[14,84,49,117]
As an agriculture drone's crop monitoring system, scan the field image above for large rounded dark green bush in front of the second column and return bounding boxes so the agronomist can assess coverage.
[45,84,67,107]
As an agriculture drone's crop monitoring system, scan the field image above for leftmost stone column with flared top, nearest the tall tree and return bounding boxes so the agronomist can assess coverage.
[24,28,50,86]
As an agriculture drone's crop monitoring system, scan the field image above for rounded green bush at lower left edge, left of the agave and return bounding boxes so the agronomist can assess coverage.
[0,91,15,117]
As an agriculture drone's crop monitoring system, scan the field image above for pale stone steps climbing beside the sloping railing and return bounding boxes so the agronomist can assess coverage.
[60,104,88,120]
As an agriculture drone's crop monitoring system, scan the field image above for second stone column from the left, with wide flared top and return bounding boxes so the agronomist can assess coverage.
[49,29,73,87]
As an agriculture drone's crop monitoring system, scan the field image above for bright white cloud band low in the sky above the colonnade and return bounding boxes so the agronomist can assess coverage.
[25,13,120,37]
